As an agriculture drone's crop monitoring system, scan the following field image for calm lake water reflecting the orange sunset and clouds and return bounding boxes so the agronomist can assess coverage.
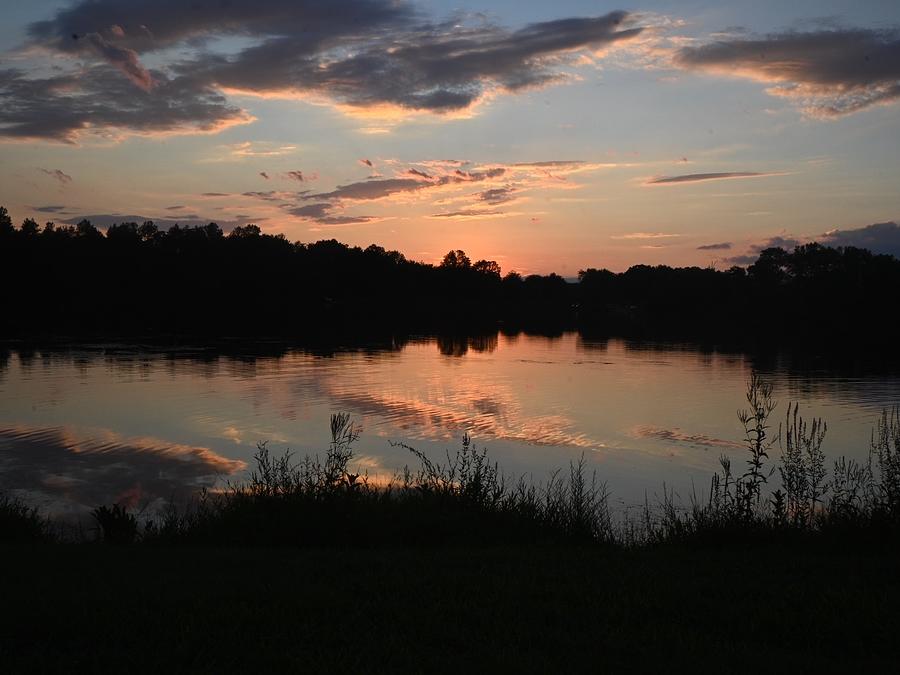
[0,333,900,515]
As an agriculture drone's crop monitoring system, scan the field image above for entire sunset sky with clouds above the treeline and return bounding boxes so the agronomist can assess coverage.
[0,0,900,276]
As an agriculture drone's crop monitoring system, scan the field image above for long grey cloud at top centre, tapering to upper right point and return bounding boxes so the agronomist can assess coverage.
[178,12,641,113]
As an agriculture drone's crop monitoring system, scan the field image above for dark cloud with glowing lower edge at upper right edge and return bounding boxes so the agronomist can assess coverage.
[674,28,900,118]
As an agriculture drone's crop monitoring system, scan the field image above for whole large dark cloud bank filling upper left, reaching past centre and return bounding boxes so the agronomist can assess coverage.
[15,0,644,140]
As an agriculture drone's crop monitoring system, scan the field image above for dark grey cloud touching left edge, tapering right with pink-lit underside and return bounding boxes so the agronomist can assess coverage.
[0,65,249,143]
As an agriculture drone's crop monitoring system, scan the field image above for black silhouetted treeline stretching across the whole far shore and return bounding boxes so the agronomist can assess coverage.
[0,207,900,349]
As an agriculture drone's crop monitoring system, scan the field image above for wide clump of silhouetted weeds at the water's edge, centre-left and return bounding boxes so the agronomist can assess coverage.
[142,414,613,547]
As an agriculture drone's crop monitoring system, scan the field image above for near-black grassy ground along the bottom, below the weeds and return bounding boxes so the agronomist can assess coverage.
[0,544,900,673]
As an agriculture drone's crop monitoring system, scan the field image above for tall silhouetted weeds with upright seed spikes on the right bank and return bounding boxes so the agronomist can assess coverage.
[619,375,900,545]
